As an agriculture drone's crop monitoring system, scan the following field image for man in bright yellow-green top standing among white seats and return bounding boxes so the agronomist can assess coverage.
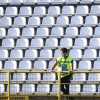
[52,48,73,94]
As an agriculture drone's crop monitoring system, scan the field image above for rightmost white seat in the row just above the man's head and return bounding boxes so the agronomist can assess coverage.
[89,38,100,49]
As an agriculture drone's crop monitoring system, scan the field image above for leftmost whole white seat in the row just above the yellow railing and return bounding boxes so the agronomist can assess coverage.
[4,60,17,70]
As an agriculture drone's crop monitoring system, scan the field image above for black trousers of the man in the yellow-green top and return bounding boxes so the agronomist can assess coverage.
[60,74,72,94]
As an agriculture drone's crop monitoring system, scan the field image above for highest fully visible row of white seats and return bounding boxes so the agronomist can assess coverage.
[0,5,100,17]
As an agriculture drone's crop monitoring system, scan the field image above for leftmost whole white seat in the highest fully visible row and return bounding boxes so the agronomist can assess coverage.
[5,7,18,17]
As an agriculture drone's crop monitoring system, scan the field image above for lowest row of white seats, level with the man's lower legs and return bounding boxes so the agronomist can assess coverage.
[0,84,100,95]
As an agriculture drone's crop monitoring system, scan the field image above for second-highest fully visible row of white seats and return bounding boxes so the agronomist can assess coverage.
[0,15,100,27]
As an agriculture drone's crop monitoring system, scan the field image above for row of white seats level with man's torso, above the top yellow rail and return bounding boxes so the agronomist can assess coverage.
[0,60,100,71]
